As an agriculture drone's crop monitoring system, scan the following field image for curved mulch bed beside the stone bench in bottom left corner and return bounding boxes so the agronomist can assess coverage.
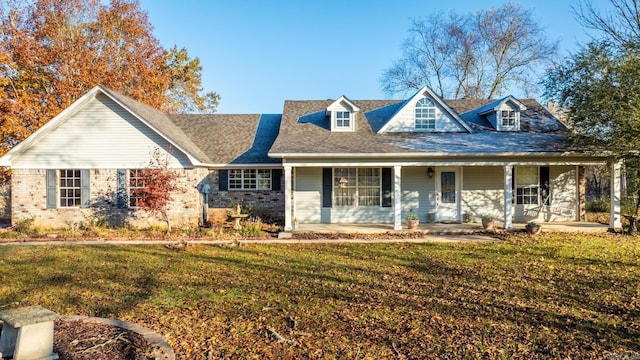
[0,320,154,360]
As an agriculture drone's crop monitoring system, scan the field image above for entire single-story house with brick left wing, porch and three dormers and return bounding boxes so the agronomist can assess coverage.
[0,86,620,231]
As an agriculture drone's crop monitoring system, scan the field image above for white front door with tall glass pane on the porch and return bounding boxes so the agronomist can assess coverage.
[436,168,460,221]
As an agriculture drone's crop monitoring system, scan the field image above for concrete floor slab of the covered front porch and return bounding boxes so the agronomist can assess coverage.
[293,222,609,235]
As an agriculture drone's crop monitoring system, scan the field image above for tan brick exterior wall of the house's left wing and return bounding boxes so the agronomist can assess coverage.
[11,168,284,228]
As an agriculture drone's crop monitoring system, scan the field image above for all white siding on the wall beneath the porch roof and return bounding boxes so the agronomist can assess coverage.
[294,166,577,223]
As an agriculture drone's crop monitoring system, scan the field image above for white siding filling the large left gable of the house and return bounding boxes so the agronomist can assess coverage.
[12,95,190,169]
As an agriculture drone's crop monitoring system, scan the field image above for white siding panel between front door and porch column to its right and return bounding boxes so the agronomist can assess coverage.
[462,166,504,220]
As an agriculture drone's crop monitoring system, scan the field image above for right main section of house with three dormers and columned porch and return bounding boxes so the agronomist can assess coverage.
[269,87,620,229]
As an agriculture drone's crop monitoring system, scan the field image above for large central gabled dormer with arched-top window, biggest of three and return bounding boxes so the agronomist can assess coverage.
[377,86,473,134]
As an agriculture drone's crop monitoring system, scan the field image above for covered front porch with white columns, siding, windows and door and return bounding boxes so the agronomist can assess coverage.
[284,159,621,232]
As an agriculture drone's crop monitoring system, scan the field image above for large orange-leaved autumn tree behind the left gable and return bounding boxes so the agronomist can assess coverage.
[0,0,219,155]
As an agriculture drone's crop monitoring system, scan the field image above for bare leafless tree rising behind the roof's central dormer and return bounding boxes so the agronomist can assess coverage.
[380,3,557,98]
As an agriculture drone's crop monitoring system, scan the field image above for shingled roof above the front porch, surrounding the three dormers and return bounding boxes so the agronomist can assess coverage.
[270,99,576,156]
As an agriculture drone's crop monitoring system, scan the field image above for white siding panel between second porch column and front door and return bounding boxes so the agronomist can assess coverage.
[402,167,435,222]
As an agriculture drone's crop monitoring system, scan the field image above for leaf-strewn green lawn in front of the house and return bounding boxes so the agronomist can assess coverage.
[0,234,640,359]
